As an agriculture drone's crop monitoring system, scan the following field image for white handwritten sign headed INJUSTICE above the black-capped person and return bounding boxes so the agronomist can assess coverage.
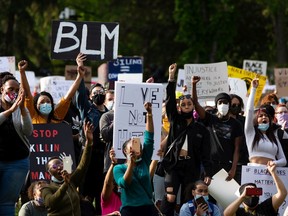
[184,62,229,101]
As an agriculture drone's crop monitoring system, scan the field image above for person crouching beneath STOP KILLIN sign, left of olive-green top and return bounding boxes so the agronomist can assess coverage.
[18,181,47,216]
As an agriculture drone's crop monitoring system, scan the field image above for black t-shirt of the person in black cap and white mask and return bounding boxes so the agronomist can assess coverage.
[204,112,244,163]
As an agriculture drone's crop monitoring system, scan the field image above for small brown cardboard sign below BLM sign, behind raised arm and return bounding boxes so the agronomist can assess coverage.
[65,65,92,89]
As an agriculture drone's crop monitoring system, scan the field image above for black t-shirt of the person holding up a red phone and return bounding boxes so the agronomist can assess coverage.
[236,197,278,216]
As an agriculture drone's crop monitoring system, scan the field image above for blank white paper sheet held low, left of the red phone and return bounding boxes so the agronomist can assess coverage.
[209,169,240,209]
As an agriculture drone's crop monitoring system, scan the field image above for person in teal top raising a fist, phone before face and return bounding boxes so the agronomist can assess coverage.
[113,102,158,216]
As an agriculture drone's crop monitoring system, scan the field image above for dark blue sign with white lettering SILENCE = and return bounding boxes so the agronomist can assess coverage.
[108,57,143,81]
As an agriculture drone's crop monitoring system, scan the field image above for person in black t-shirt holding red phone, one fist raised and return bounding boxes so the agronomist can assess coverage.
[224,161,287,216]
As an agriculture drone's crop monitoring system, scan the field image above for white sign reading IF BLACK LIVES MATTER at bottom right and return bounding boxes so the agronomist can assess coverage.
[241,166,288,215]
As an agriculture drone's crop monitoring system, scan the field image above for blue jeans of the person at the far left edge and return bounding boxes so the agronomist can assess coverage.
[0,158,30,216]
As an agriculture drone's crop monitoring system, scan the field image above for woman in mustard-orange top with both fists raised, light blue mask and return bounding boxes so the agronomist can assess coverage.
[18,60,85,124]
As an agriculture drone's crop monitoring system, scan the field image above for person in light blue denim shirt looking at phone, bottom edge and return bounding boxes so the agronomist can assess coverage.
[179,180,221,216]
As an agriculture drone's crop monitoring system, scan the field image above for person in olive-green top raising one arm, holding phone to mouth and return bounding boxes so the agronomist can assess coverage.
[41,121,94,216]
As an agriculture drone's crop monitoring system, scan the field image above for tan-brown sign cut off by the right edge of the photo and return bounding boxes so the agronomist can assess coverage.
[274,68,288,97]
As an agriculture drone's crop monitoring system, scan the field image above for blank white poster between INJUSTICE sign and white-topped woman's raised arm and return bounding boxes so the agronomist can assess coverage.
[228,77,248,110]
